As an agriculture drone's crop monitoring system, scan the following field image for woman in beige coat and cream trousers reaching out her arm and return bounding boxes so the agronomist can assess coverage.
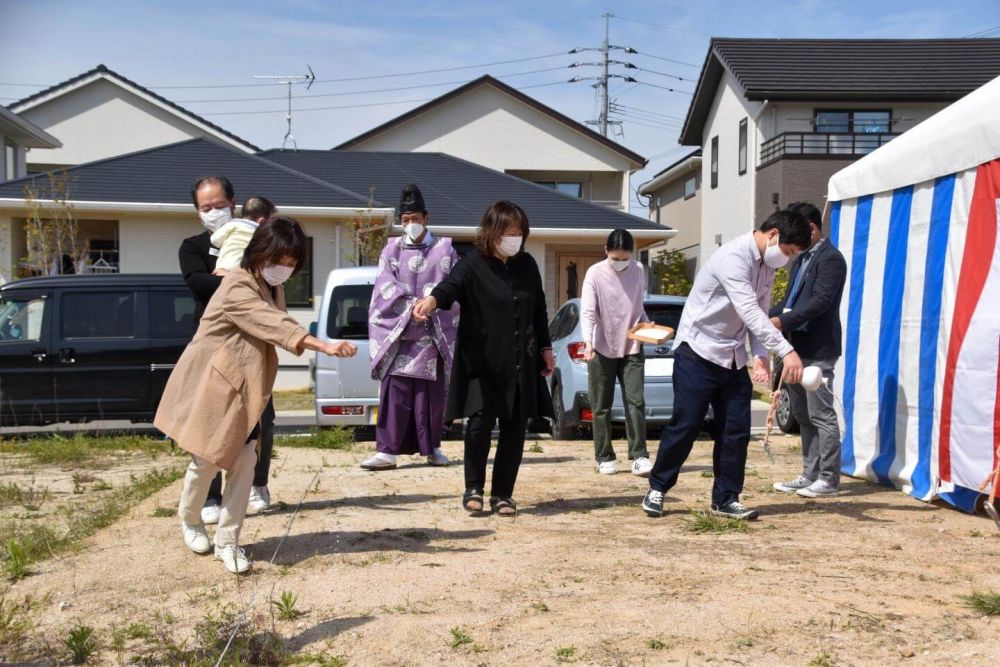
[153,217,357,573]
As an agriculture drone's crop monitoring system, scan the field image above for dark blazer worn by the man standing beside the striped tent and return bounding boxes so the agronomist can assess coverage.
[770,239,847,360]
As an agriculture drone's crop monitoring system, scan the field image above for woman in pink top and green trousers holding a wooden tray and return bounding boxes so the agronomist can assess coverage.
[580,229,653,477]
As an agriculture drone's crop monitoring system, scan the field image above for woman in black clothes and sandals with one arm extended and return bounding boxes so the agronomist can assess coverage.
[414,201,555,516]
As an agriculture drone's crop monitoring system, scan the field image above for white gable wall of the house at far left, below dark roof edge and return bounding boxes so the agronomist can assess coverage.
[20,79,219,165]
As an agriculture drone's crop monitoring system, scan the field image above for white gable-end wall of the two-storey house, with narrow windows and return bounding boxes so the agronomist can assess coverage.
[699,71,761,264]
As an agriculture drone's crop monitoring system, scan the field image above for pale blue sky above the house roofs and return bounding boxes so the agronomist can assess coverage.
[0,0,1000,212]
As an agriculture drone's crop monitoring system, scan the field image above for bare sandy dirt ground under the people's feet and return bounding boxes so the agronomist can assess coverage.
[1,437,1000,665]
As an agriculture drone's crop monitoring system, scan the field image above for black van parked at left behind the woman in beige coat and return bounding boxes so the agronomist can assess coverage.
[0,274,194,426]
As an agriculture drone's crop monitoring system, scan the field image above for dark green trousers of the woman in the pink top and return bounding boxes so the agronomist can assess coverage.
[587,351,649,463]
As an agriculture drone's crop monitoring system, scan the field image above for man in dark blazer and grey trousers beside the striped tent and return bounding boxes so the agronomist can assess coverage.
[770,202,847,498]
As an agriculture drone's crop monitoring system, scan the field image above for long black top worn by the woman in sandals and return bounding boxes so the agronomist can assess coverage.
[431,251,552,419]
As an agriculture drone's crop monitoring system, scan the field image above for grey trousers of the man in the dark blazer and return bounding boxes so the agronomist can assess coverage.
[786,359,840,488]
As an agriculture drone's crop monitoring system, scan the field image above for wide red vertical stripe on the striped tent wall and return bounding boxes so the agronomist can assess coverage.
[938,160,1000,482]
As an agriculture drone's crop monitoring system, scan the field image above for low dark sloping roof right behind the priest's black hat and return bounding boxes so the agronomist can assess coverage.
[261,149,668,232]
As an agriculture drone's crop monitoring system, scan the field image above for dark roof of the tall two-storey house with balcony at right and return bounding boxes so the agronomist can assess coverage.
[680,37,1000,146]
